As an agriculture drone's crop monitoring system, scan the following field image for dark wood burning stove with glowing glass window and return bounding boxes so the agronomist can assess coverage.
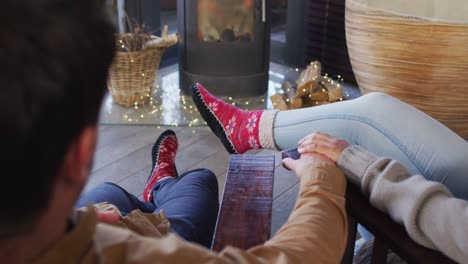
[177,0,270,97]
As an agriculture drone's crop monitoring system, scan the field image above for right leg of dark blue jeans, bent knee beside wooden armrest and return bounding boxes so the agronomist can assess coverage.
[153,169,219,248]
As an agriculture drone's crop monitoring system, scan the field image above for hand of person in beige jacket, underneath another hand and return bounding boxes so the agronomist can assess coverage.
[283,153,335,178]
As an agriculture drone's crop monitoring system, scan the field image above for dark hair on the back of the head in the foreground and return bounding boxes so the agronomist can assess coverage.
[0,0,115,237]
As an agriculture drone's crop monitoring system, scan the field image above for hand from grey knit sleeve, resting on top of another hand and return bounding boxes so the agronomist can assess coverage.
[297,132,349,162]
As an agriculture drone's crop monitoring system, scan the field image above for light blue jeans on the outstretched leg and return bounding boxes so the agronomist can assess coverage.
[273,93,468,199]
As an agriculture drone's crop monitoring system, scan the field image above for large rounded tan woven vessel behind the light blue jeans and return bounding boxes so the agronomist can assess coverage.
[345,0,468,138]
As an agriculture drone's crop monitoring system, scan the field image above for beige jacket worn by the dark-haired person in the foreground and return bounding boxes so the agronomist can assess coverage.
[36,165,347,263]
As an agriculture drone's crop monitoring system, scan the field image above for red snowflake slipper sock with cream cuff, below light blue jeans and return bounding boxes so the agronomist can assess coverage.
[192,83,277,154]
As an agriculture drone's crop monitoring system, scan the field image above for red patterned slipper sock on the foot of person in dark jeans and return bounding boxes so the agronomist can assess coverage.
[143,130,178,202]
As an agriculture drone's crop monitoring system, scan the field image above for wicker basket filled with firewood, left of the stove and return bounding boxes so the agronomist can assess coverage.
[107,48,165,107]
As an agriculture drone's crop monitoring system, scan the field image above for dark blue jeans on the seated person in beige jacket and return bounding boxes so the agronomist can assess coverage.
[75,169,219,247]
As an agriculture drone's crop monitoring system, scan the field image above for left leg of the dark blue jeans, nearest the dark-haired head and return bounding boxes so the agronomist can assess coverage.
[75,182,156,216]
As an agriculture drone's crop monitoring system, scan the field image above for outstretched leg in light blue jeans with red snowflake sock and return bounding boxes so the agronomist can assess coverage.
[192,84,468,199]
